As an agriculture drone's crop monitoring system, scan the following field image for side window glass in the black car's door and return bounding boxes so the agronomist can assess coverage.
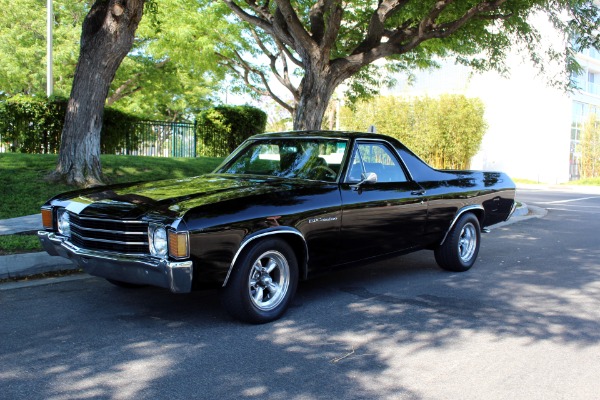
[347,142,407,182]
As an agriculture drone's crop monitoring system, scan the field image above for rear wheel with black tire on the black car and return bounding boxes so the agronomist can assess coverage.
[434,213,481,272]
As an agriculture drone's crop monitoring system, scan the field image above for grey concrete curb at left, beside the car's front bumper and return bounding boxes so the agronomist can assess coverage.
[0,251,78,279]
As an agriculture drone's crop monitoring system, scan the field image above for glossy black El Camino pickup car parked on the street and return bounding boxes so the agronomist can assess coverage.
[38,131,515,323]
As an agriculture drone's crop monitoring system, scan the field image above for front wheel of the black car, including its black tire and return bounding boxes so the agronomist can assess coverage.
[221,239,298,324]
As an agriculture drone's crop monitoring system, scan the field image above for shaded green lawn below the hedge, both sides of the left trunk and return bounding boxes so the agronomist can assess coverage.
[0,153,223,219]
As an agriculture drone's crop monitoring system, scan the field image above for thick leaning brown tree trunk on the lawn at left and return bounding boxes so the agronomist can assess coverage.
[50,0,145,186]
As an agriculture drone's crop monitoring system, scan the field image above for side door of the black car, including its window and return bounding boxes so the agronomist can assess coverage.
[340,140,427,262]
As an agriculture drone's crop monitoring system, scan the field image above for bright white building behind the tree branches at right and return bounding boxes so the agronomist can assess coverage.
[392,18,600,183]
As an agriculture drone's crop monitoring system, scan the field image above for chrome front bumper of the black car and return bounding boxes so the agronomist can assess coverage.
[38,231,193,293]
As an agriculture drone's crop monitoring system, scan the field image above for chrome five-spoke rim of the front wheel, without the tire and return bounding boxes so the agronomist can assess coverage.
[248,250,290,311]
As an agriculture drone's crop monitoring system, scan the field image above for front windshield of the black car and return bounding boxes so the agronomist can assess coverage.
[215,138,348,182]
